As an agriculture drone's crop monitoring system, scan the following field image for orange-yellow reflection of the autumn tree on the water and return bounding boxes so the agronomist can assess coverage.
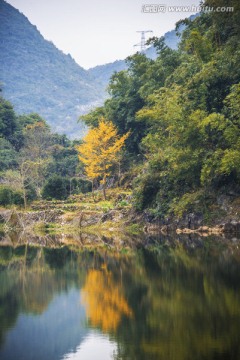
[81,270,132,331]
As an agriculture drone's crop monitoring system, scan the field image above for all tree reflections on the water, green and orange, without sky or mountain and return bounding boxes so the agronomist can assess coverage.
[0,240,240,360]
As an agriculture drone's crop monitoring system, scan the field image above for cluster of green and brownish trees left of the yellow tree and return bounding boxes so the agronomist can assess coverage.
[0,98,91,206]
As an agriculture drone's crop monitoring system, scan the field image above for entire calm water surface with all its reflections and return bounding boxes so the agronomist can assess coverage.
[0,238,240,360]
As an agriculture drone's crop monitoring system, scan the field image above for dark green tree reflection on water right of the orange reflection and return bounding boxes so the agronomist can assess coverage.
[116,247,240,360]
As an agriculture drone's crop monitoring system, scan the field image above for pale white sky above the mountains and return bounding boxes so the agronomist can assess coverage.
[6,0,200,69]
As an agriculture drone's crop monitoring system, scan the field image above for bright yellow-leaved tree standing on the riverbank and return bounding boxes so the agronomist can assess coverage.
[77,118,129,200]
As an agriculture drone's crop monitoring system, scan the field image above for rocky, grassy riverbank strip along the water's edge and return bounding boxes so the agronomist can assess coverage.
[0,189,240,246]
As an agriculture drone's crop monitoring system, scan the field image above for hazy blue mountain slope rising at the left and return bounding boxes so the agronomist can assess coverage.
[0,0,104,136]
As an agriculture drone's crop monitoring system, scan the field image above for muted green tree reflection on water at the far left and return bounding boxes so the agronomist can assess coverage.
[0,245,82,346]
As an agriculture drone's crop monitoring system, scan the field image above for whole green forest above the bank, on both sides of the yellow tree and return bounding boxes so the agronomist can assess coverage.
[0,0,240,225]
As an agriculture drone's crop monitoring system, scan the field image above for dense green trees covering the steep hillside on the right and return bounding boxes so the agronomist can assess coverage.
[83,0,240,217]
